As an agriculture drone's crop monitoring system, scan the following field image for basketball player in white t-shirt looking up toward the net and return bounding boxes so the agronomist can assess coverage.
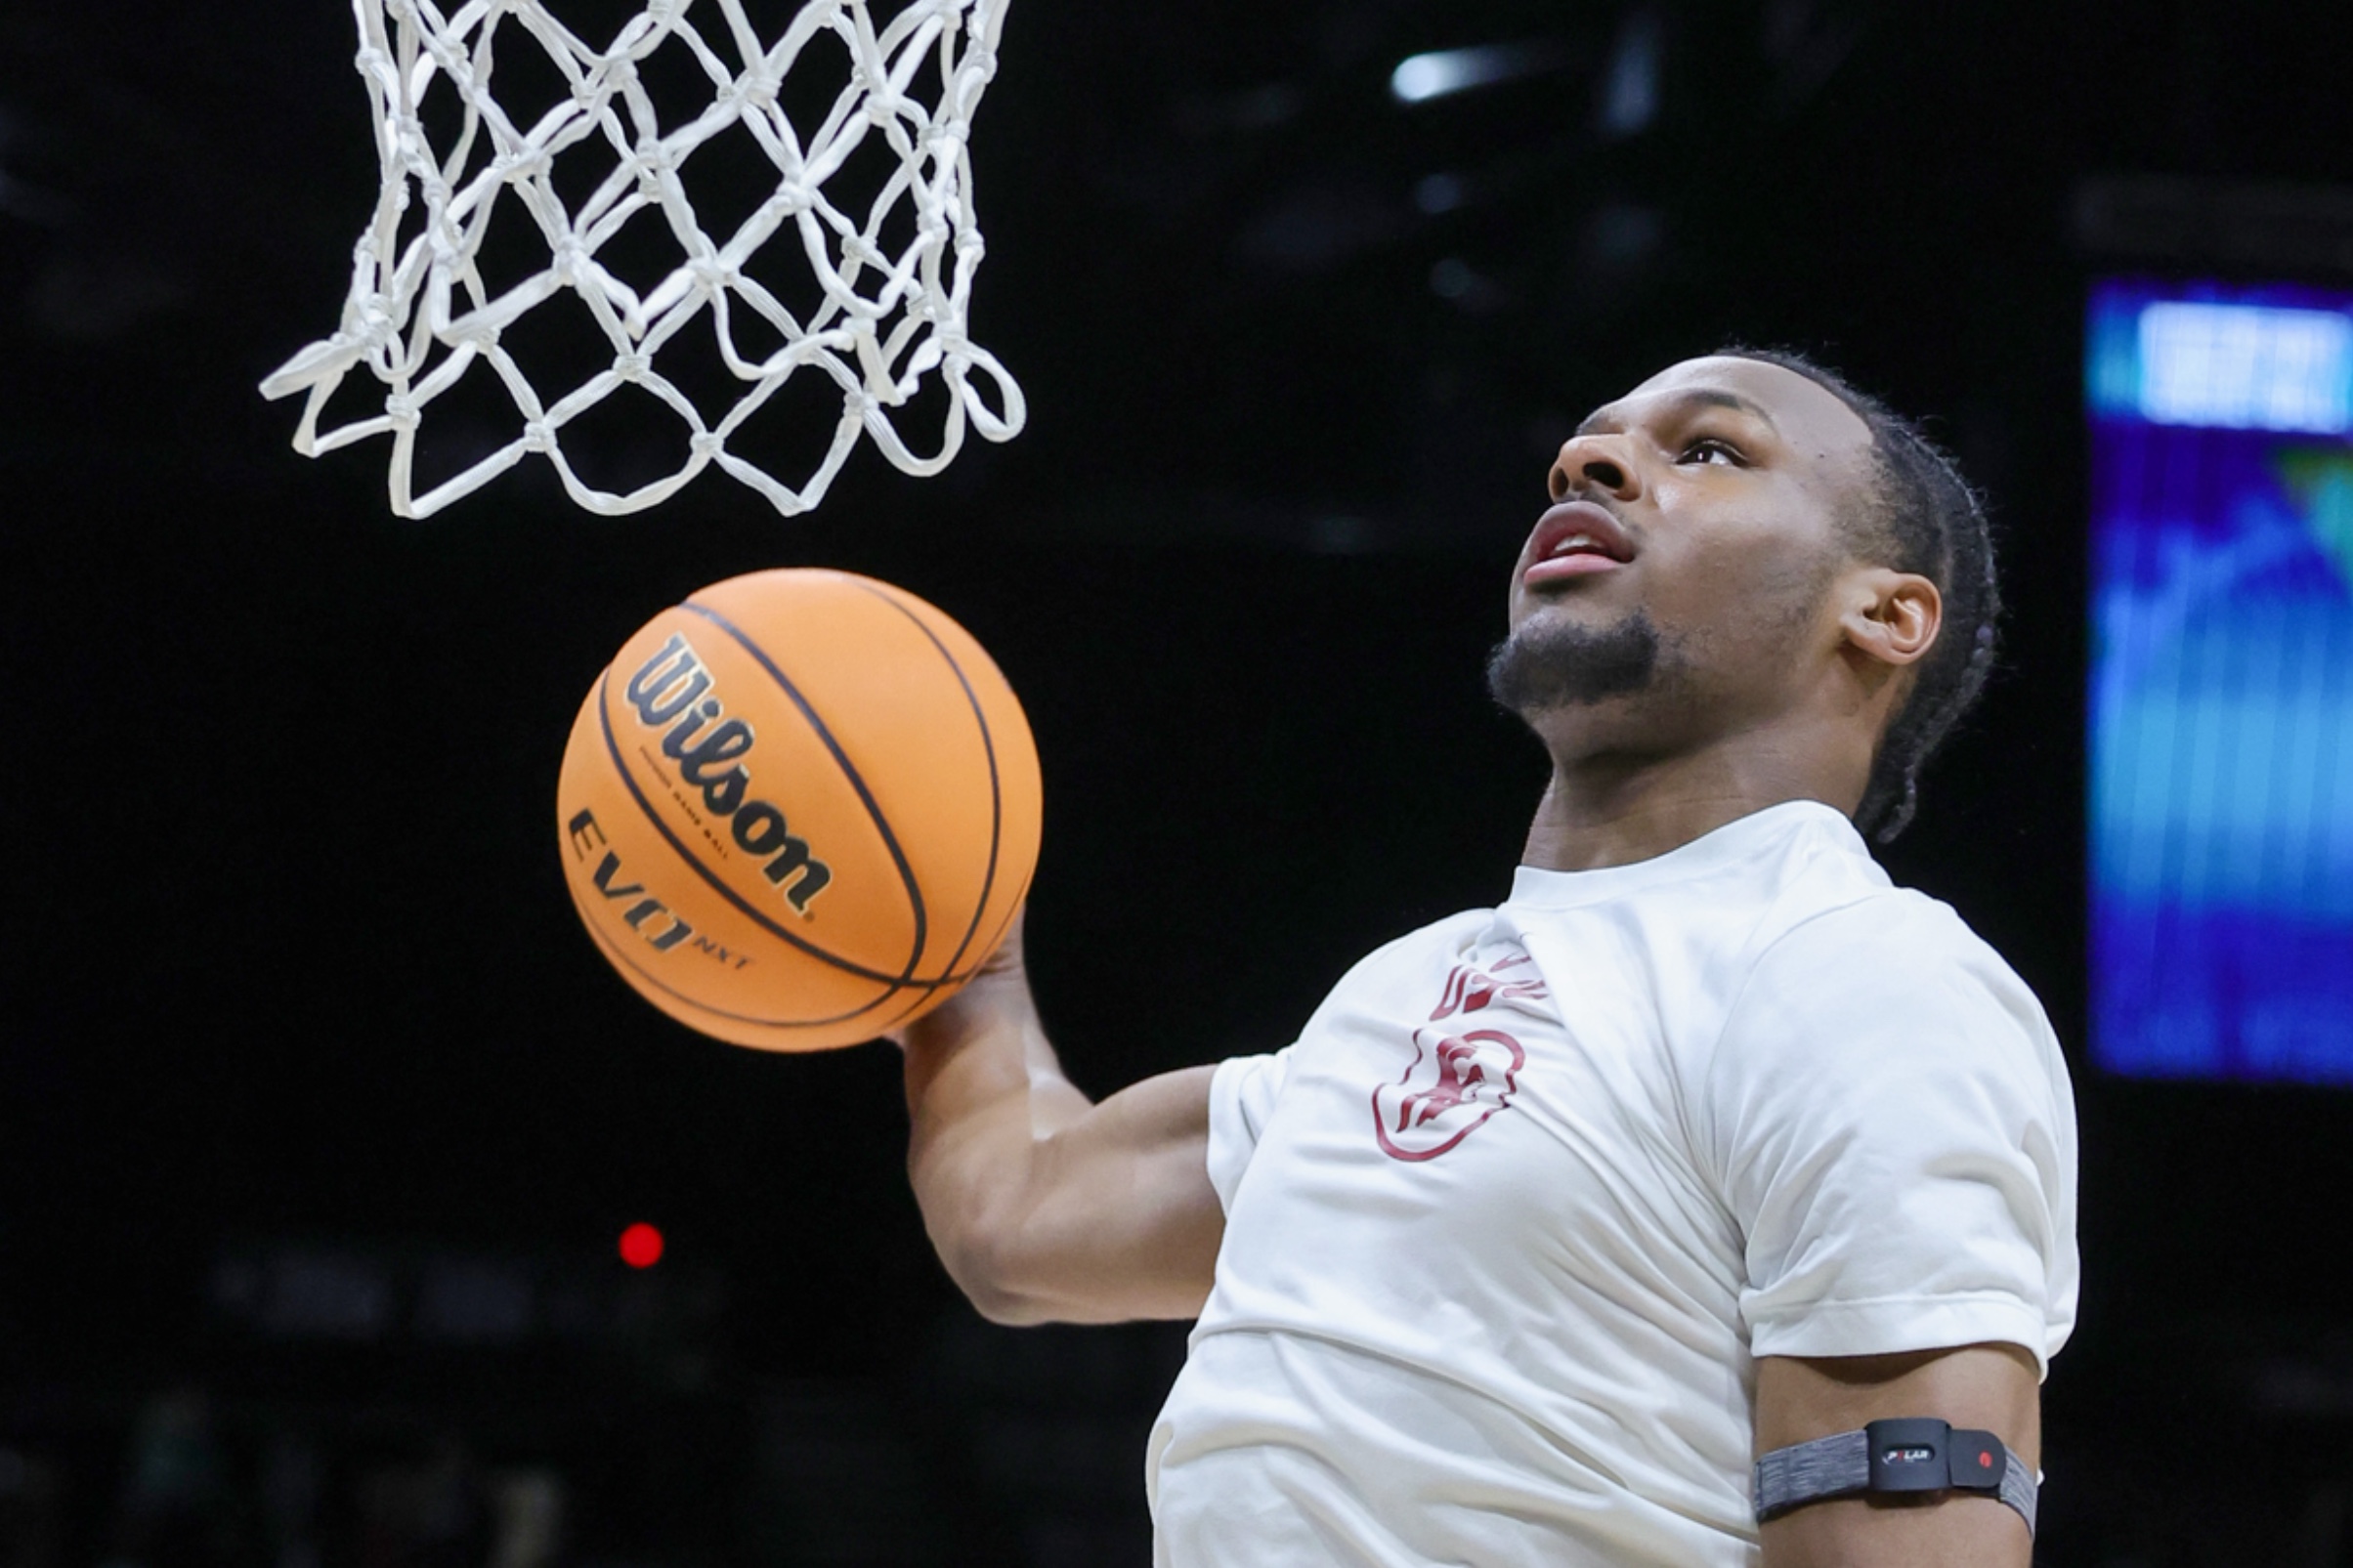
[904,351,2075,1568]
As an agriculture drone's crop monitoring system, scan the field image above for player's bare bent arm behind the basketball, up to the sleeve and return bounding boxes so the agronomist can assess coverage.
[901,921,1226,1324]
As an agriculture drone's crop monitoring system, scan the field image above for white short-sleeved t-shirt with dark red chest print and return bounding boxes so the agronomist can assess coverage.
[1146,802,2075,1568]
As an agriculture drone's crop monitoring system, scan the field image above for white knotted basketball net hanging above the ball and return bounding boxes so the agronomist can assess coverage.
[261,0,1023,517]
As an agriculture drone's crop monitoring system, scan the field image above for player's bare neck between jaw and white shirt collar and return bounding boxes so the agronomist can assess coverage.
[1520,729,1870,872]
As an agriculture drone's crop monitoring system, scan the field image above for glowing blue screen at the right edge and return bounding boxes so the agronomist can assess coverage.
[2087,279,2353,1083]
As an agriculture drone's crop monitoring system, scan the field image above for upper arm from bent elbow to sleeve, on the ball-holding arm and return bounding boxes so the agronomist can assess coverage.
[1000,1067,1226,1321]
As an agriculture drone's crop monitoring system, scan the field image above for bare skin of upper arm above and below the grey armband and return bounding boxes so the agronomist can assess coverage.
[1755,1344,2042,1568]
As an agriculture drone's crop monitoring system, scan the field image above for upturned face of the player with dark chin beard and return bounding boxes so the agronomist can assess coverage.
[1511,358,1870,724]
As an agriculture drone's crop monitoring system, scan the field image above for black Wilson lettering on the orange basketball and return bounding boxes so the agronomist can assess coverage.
[621,632,833,914]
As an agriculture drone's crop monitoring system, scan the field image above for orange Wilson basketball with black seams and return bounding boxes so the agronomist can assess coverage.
[555,569,1040,1051]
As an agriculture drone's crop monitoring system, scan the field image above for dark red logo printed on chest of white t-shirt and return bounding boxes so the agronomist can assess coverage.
[1372,953,1546,1162]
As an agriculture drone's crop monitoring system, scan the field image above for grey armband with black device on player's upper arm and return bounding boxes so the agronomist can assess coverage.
[1751,1418,2040,1535]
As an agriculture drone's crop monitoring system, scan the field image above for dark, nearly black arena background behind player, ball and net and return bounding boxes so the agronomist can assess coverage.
[14,0,2353,1568]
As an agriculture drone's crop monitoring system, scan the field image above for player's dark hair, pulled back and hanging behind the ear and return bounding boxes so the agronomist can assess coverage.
[1715,346,2002,844]
